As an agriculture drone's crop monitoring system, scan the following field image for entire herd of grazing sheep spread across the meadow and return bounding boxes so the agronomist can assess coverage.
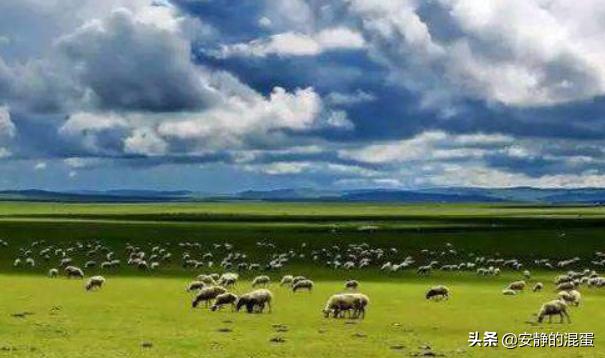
[0,236,605,322]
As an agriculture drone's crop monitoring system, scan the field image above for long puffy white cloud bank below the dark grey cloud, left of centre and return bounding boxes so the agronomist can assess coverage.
[59,84,353,156]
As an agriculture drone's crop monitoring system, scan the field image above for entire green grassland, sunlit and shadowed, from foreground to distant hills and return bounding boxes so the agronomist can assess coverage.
[0,203,605,357]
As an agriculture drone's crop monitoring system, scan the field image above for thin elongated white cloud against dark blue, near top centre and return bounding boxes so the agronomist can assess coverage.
[216,27,365,58]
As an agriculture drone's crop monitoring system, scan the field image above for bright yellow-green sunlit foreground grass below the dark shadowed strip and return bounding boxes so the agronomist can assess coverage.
[0,275,605,357]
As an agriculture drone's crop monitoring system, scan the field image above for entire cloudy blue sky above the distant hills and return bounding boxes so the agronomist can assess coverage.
[0,0,605,193]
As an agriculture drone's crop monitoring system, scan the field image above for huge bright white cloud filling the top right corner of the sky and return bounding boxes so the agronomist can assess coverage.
[349,0,605,106]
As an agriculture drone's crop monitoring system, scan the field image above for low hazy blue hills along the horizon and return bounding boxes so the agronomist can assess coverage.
[0,187,605,205]
